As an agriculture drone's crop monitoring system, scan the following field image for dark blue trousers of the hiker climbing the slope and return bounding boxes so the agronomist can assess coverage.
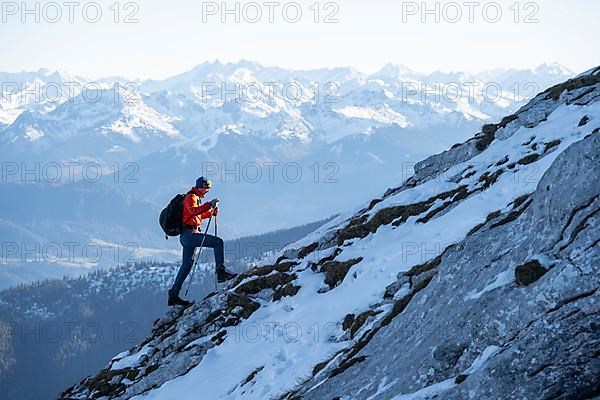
[171,230,225,295]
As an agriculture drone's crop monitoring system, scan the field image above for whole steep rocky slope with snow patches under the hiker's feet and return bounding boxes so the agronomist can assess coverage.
[63,68,600,400]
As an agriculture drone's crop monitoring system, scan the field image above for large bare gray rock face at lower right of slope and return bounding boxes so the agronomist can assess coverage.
[299,133,600,399]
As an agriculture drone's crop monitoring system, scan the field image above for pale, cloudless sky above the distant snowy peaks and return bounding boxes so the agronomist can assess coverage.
[0,0,600,79]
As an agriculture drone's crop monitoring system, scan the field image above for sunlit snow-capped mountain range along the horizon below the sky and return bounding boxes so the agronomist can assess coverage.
[0,61,573,154]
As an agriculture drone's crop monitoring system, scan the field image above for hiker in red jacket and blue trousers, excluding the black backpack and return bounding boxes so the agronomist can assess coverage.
[169,177,236,306]
